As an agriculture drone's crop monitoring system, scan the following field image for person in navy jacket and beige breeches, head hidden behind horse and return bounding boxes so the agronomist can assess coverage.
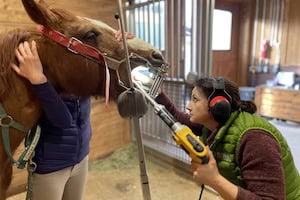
[12,41,92,200]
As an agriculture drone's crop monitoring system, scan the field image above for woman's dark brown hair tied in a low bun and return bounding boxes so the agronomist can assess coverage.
[195,77,257,114]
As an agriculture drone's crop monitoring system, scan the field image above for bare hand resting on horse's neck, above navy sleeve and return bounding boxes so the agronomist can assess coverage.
[11,41,47,84]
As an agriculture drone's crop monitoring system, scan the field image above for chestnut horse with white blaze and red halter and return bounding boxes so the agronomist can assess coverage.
[0,0,165,200]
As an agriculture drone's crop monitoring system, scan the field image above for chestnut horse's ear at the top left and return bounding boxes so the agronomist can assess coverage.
[22,0,55,27]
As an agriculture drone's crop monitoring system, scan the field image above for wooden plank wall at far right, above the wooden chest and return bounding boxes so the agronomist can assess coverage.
[252,0,300,66]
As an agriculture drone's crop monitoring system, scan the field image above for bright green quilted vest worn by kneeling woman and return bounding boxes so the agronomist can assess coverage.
[207,112,300,200]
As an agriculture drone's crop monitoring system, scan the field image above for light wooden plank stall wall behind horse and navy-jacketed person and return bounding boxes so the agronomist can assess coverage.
[0,0,130,197]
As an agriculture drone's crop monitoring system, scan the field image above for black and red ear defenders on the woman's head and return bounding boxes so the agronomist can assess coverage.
[208,77,232,124]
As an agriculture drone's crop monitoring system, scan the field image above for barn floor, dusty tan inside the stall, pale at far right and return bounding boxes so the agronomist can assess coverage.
[8,120,300,200]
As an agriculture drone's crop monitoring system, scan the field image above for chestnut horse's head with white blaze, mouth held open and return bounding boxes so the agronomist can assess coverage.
[22,0,164,98]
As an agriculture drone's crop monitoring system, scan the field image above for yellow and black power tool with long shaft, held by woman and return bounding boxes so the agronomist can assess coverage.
[133,80,208,164]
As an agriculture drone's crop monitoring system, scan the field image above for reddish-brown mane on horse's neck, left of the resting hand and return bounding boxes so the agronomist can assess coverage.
[0,29,37,99]
